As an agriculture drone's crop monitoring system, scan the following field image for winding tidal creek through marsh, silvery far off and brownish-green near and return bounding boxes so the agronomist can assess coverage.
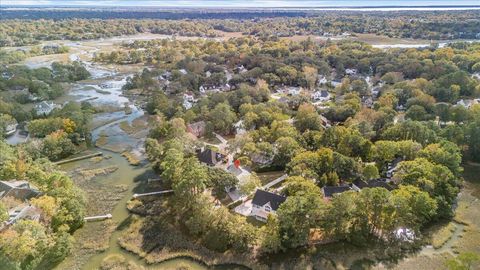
[48,49,240,270]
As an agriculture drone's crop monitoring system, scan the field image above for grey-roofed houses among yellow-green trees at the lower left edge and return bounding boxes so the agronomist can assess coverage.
[0,180,41,230]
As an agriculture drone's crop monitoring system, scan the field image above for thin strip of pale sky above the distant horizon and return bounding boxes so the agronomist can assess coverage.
[0,0,480,8]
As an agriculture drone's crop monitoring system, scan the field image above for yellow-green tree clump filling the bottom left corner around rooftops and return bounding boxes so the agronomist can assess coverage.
[0,141,85,269]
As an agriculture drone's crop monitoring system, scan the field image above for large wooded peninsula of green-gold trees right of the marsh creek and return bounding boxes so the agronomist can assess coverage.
[122,34,480,253]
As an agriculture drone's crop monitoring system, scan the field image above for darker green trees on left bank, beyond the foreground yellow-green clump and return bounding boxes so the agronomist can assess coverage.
[0,62,95,160]
